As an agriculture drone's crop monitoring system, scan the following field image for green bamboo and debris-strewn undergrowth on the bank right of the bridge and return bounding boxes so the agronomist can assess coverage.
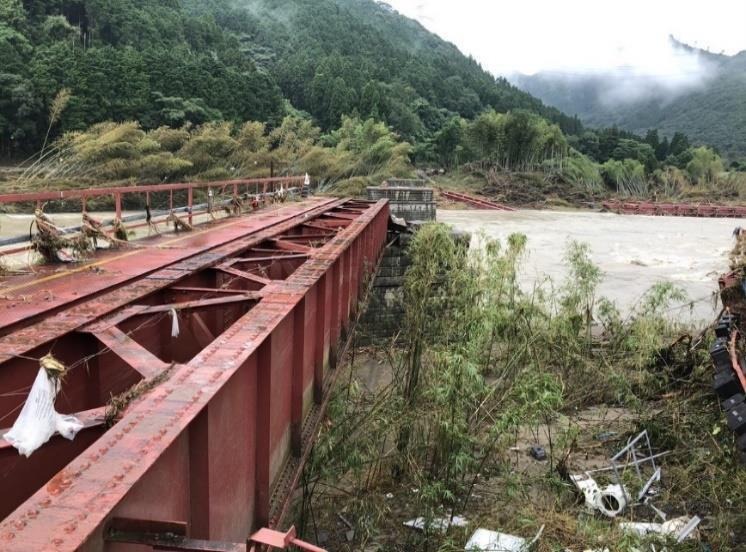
[299,224,746,552]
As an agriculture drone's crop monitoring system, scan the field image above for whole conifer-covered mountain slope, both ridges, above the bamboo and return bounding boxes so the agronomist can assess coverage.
[0,0,579,155]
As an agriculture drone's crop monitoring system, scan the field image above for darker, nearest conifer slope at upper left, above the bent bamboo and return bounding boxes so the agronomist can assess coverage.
[0,0,284,155]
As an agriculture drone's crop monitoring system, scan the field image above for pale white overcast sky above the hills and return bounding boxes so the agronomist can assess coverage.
[387,0,746,76]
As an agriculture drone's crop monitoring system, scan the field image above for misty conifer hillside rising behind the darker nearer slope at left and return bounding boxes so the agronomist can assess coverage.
[185,0,579,141]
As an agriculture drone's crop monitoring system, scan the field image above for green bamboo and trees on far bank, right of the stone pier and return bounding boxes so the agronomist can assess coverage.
[432,110,746,205]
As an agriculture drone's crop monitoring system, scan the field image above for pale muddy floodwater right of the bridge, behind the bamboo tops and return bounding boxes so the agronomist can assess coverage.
[438,210,746,322]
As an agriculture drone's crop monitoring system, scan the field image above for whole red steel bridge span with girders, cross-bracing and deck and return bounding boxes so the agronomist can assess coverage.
[0,196,388,551]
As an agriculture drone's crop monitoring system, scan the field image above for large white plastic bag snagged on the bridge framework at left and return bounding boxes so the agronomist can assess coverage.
[3,368,83,458]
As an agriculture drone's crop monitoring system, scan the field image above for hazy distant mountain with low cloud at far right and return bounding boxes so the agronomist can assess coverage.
[511,38,746,159]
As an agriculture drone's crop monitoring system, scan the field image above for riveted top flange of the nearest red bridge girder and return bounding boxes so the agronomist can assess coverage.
[0,200,386,550]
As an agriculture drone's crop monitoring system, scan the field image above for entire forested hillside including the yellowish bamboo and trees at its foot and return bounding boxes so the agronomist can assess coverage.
[0,0,743,204]
